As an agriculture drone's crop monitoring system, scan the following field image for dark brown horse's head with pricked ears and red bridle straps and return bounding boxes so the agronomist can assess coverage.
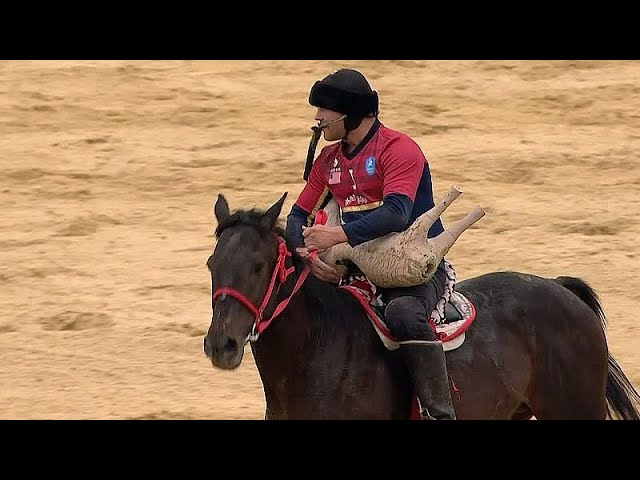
[204,193,287,369]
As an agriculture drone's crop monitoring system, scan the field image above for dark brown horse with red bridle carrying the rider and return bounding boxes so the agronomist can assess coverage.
[204,194,640,420]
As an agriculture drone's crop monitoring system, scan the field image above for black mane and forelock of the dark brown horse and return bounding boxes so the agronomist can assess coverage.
[215,208,366,340]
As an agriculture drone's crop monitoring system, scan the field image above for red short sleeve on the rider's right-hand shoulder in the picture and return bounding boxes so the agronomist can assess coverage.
[380,137,427,202]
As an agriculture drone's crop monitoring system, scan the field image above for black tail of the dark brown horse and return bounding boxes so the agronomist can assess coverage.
[555,277,640,420]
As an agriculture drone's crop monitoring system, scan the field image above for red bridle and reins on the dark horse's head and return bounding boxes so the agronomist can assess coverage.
[213,210,327,341]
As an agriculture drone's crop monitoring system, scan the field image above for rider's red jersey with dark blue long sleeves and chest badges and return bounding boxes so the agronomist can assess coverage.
[287,121,443,246]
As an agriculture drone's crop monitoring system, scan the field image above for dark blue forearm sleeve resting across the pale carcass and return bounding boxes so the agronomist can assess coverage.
[342,193,413,247]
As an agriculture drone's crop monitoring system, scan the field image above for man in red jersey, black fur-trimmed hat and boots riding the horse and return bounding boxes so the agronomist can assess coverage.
[286,69,456,420]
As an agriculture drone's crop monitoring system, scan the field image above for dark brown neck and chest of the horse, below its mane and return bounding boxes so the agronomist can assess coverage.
[252,282,407,418]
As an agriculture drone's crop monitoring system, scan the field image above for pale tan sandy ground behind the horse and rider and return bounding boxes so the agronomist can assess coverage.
[0,61,640,419]
